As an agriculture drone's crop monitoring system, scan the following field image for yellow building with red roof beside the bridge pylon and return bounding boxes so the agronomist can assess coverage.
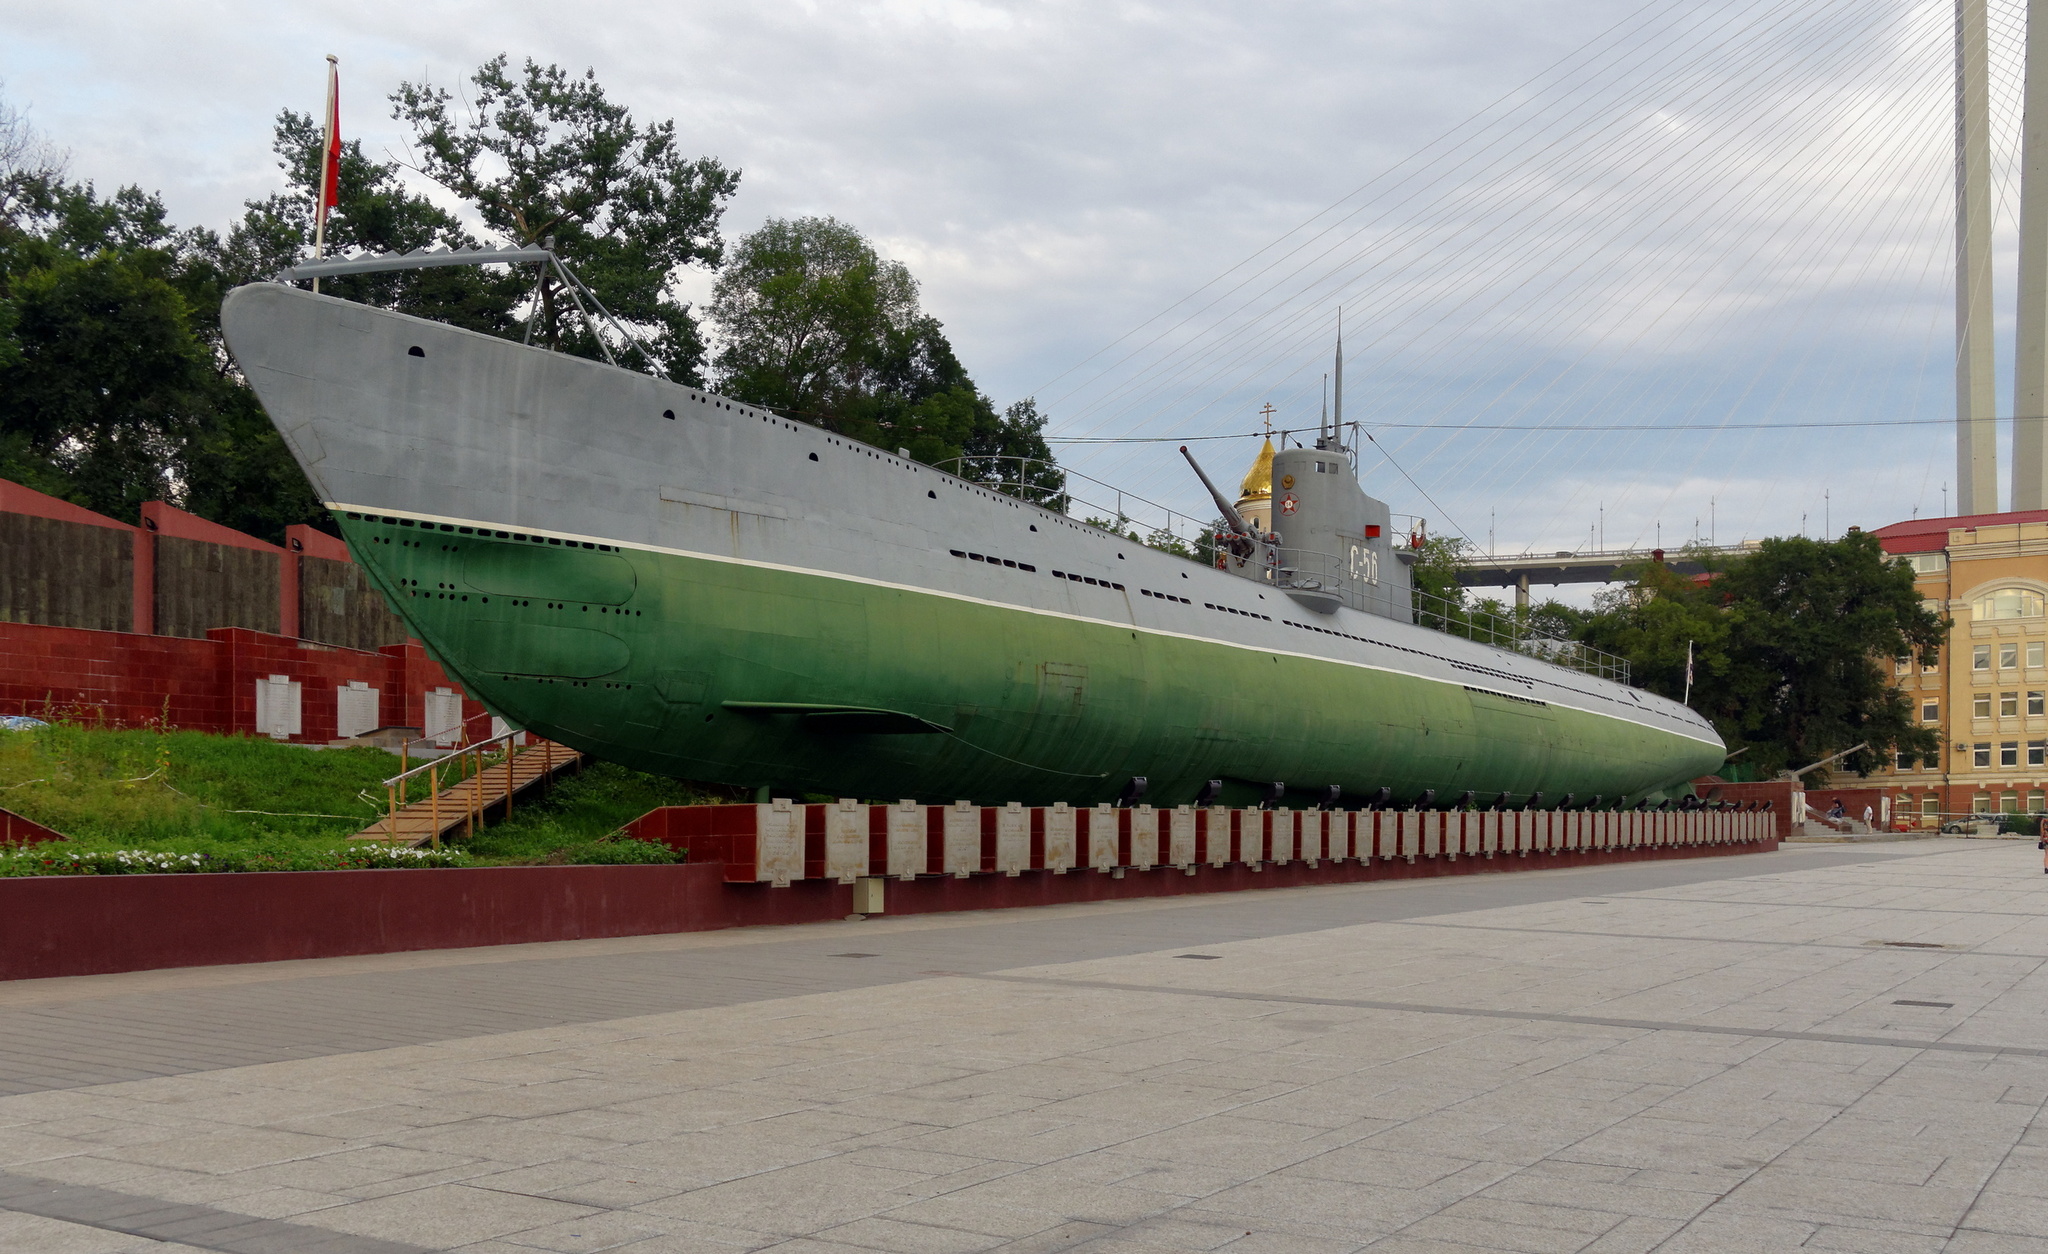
[1872,510,2048,828]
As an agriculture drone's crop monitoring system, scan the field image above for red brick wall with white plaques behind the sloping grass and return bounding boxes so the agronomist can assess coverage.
[0,623,489,744]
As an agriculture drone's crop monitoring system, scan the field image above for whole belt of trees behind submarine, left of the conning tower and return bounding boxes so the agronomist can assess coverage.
[0,75,1065,541]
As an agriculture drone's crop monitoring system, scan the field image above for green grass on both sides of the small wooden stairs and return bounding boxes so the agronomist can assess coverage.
[0,723,729,873]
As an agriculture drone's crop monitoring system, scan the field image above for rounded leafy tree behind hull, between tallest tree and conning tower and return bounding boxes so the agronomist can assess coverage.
[709,217,1065,499]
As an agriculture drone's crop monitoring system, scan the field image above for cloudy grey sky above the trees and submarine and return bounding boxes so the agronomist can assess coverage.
[0,0,2013,577]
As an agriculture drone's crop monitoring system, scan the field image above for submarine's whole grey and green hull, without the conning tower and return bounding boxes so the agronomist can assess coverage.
[223,285,1724,803]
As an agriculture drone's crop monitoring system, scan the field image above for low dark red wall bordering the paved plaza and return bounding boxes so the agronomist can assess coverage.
[0,840,1778,979]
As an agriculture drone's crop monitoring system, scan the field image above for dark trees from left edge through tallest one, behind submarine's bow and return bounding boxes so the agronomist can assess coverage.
[0,57,753,541]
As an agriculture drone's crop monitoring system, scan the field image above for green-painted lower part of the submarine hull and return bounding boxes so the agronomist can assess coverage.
[338,514,1722,805]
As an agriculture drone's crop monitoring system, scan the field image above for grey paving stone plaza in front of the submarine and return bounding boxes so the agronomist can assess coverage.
[0,840,2048,1254]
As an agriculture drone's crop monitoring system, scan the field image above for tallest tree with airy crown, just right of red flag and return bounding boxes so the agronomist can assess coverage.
[391,53,739,383]
